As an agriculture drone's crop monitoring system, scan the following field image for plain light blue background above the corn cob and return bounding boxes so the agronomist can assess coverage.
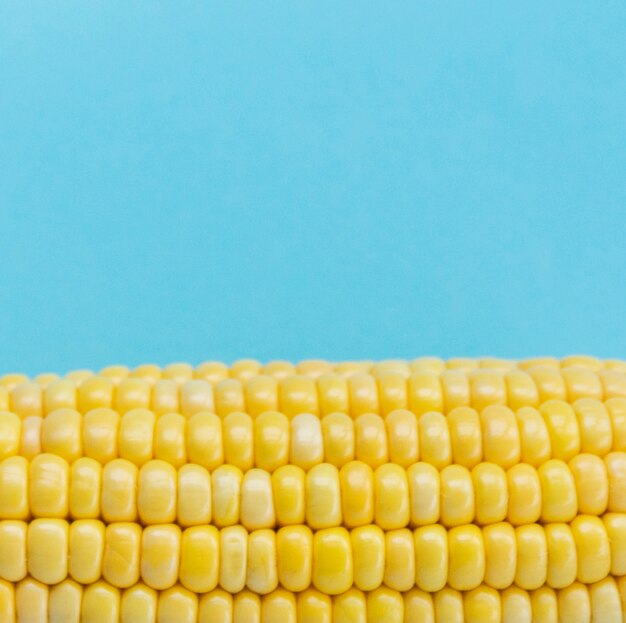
[0,0,626,373]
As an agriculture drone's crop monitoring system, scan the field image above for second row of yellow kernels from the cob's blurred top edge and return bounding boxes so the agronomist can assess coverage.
[0,367,626,417]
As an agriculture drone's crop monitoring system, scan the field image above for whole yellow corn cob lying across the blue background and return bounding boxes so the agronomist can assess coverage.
[0,356,626,623]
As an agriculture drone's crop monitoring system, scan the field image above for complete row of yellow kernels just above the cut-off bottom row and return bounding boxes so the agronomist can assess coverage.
[0,514,626,595]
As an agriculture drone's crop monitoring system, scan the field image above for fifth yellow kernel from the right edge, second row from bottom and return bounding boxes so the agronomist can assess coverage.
[483,522,517,589]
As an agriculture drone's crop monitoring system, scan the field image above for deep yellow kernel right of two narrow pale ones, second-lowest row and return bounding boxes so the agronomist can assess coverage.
[276,526,313,592]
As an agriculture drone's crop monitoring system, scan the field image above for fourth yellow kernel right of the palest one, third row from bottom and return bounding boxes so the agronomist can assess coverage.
[374,463,411,530]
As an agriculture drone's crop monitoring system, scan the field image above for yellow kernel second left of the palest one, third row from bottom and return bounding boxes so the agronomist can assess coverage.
[176,463,211,528]
